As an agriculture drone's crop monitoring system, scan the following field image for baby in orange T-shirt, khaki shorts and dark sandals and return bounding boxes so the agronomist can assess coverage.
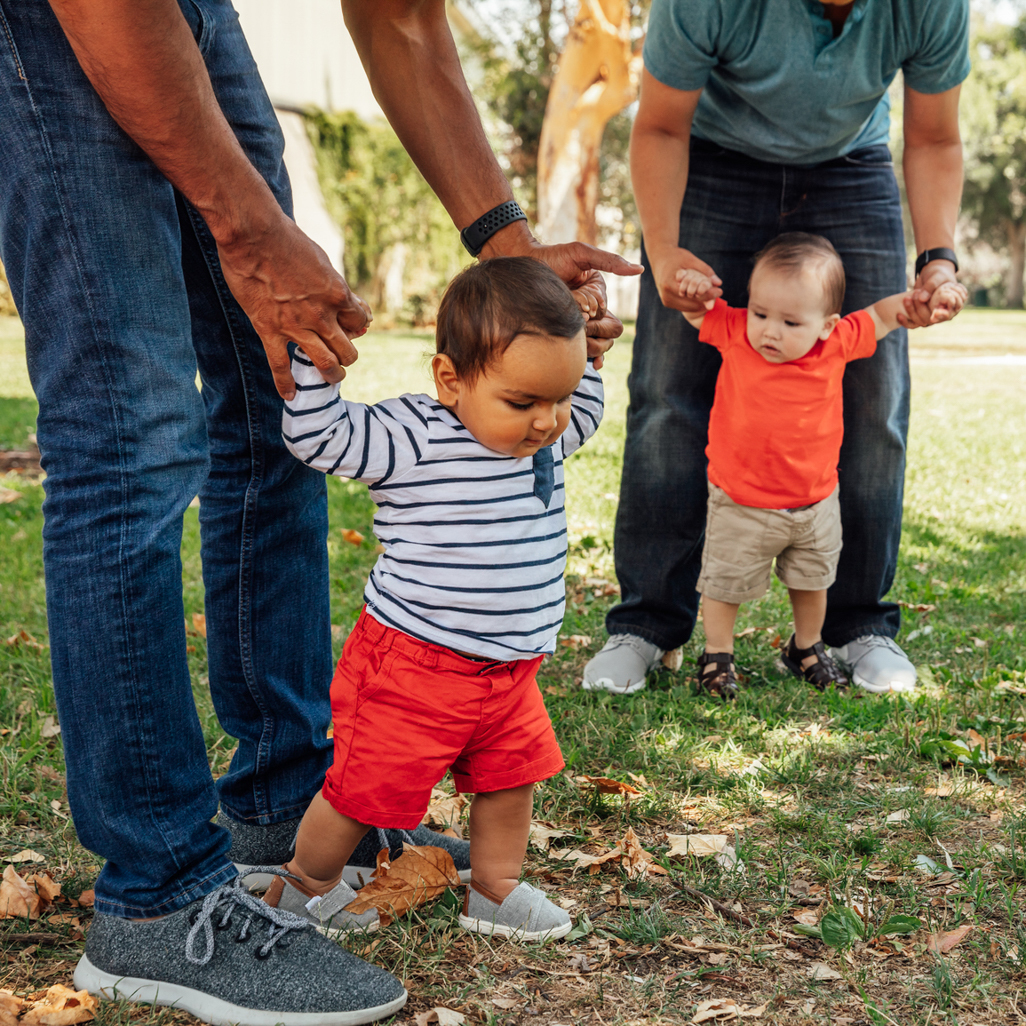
[678,232,964,699]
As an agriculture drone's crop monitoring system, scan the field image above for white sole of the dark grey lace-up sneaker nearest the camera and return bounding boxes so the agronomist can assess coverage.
[75,955,408,1026]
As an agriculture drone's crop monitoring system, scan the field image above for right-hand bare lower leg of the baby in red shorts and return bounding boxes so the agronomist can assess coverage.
[470,784,535,901]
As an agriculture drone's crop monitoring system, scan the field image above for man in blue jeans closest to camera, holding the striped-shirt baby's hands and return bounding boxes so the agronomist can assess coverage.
[0,0,640,1026]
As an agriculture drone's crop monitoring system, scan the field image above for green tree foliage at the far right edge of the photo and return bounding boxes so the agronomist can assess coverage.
[961,17,1026,307]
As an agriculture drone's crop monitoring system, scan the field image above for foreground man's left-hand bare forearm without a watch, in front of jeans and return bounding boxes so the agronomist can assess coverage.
[50,0,282,245]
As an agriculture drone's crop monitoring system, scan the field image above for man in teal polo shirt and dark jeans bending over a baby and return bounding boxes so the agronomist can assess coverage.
[584,0,969,694]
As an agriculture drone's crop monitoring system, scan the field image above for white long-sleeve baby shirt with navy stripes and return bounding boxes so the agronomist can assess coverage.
[282,352,602,660]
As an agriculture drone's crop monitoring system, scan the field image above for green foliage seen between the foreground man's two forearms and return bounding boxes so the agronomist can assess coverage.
[299,111,470,323]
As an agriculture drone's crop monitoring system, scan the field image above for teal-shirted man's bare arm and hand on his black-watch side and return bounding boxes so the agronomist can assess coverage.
[900,86,962,327]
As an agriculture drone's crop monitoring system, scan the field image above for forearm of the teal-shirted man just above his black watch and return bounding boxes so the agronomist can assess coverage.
[903,141,962,252]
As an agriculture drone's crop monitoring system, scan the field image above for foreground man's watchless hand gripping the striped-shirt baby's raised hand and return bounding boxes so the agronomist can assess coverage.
[218,214,371,399]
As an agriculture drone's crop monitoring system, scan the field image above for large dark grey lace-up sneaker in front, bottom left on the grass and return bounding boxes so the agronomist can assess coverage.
[75,866,406,1026]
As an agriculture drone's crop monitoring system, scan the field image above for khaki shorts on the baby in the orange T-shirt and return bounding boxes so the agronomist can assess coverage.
[697,481,841,602]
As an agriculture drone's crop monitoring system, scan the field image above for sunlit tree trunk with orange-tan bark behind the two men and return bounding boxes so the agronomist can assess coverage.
[538,0,641,244]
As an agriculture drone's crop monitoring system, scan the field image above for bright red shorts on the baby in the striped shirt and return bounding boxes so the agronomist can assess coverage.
[322,609,564,830]
